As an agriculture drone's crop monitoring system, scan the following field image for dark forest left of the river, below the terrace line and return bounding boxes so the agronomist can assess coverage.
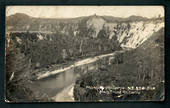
[6,28,120,100]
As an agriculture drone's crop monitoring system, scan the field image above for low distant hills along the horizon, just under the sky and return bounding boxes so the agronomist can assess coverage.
[6,13,151,26]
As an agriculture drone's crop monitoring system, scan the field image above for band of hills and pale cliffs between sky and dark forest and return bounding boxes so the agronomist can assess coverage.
[6,13,164,48]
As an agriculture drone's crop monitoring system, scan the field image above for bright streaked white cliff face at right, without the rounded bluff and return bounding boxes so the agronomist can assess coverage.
[105,20,164,48]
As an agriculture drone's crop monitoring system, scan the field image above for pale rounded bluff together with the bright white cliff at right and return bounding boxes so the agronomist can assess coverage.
[86,16,164,48]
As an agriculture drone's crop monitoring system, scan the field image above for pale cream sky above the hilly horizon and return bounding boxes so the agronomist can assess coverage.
[6,6,164,18]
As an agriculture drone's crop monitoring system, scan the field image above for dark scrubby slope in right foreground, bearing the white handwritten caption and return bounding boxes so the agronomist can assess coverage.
[74,29,164,101]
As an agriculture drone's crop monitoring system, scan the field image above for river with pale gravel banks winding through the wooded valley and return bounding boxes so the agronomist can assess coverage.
[31,51,124,102]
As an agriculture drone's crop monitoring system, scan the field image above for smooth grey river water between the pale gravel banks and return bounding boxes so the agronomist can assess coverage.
[32,63,97,97]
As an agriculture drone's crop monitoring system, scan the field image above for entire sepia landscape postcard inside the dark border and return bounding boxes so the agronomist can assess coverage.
[5,5,165,102]
